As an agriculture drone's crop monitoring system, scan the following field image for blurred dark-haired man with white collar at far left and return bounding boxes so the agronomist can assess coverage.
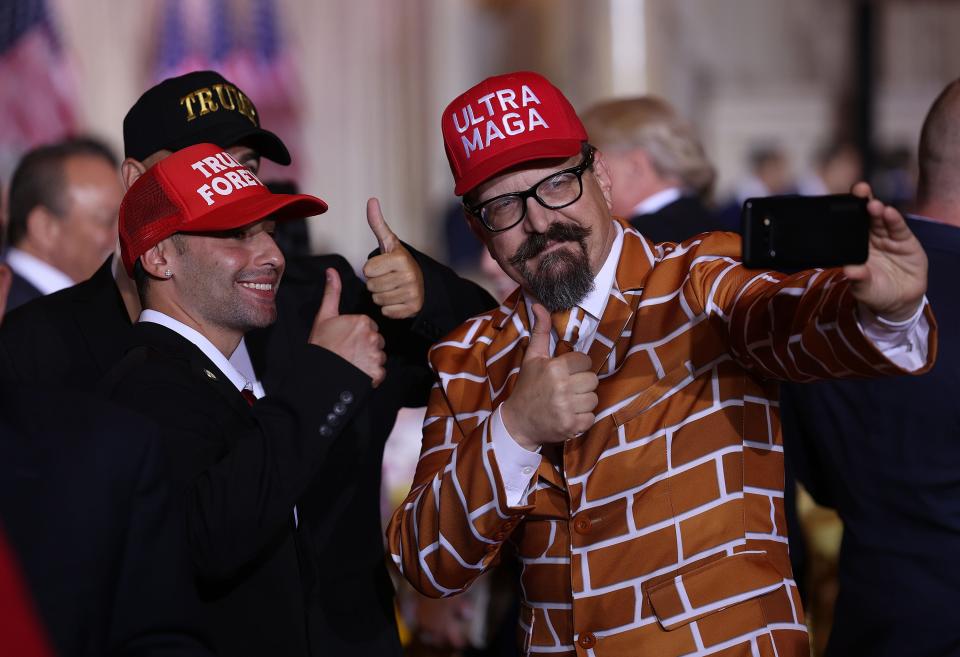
[6,139,123,311]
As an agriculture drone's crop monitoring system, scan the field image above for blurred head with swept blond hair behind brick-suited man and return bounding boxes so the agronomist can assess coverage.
[581,96,715,215]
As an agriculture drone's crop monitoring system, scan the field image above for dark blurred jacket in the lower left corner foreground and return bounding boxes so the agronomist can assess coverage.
[0,386,210,657]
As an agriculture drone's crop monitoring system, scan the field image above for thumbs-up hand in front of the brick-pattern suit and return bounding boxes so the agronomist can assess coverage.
[500,304,599,452]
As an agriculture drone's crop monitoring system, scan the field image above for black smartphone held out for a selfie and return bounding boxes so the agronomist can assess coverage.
[740,194,870,271]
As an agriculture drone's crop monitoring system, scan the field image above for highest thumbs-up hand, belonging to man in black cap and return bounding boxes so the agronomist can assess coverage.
[363,198,424,319]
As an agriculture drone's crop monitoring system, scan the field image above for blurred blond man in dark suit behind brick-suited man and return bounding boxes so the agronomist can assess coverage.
[582,96,719,242]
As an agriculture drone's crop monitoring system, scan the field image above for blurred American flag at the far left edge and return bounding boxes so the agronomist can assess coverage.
[0,0,77,180]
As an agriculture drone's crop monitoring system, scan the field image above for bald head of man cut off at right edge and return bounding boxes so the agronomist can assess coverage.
[917,80,960,225]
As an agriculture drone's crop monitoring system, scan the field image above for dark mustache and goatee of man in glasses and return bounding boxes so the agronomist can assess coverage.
[510,222,593,313]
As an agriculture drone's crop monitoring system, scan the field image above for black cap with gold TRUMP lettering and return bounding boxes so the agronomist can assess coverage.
[123,71,290,164]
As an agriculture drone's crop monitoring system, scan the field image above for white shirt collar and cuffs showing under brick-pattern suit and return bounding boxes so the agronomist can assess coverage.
[490,223,930,506]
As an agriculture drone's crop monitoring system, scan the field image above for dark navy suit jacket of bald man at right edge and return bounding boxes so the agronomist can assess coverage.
[782,219,960,657]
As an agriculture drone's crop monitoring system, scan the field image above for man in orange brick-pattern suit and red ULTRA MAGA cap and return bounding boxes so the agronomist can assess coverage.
[387,73,936,657]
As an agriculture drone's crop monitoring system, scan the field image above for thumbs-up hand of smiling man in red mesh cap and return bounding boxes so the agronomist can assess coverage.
[308,267,387,388]
